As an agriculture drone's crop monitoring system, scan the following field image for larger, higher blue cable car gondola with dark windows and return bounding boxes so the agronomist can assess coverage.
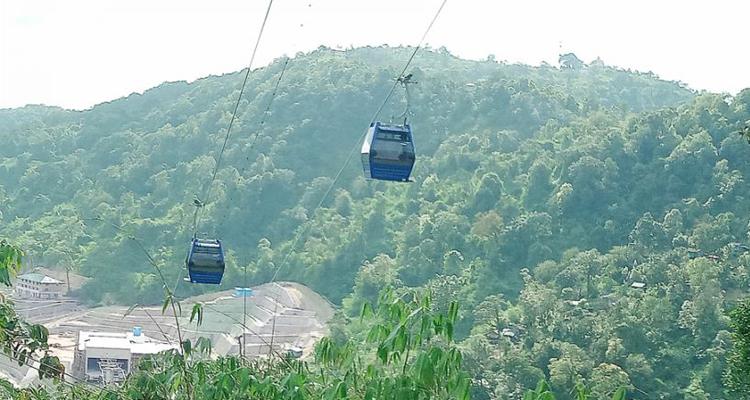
[362,122,416,182]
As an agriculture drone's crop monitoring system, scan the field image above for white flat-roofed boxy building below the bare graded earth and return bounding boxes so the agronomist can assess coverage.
[72,328,177,384]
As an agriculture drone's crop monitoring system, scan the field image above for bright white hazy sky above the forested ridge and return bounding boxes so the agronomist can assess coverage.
[0,0,750,109]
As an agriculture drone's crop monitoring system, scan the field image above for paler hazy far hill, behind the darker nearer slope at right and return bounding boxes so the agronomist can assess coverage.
[0,48,692,302]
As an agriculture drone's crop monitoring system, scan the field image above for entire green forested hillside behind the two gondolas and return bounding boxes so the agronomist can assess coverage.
[0,48,750,399]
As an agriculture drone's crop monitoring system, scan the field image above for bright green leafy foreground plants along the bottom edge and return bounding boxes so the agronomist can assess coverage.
[0,242,624,400]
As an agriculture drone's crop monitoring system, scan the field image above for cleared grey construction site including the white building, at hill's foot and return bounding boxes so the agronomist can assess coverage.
[0,272,334,387]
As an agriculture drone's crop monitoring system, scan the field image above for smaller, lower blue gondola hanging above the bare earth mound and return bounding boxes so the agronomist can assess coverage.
[185,238,224,285]
